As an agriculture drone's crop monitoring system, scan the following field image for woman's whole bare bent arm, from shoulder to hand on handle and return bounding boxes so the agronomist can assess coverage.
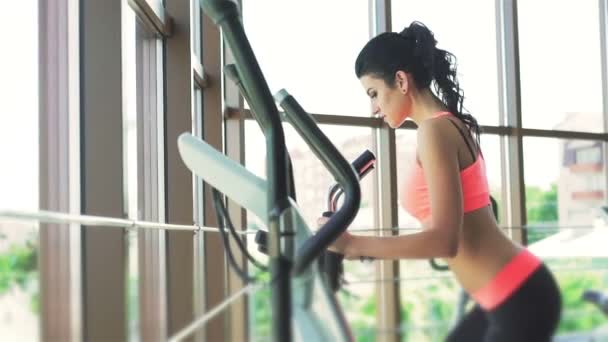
[332,120,463,259]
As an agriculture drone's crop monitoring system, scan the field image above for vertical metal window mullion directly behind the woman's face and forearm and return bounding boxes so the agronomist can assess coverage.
[368,0,401,341]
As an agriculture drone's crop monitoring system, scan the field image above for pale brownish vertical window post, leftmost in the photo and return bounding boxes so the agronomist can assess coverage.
[38,0,82,340]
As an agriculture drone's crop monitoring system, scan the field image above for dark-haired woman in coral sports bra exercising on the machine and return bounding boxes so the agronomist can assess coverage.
[319,22,561,342]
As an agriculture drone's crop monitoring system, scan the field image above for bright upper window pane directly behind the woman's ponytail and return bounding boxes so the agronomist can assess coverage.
[391,0,498,125]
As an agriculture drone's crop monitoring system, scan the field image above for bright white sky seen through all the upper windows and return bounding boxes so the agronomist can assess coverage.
[0,0,602,208]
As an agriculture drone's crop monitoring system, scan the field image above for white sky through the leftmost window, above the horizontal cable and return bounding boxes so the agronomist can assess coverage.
[0,0,38,209]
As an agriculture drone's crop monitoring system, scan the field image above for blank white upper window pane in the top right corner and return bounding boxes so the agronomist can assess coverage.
[517,0,604,132]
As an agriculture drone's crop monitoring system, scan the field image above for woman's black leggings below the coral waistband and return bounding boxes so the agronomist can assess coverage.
[446,264,561,342]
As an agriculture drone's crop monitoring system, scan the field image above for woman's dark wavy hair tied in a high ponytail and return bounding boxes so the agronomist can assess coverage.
[355,21,480,144]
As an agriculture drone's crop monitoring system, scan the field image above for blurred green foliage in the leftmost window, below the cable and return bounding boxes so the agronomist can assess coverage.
[0,241,40,313]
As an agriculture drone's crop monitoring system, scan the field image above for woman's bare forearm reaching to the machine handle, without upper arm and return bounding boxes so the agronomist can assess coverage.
[346,230,458,259]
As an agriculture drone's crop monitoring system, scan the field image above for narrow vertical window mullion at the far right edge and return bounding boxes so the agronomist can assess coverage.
[599,0,608,198]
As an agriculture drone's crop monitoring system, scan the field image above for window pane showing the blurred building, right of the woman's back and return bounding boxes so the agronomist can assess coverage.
[524,138,608,257]
